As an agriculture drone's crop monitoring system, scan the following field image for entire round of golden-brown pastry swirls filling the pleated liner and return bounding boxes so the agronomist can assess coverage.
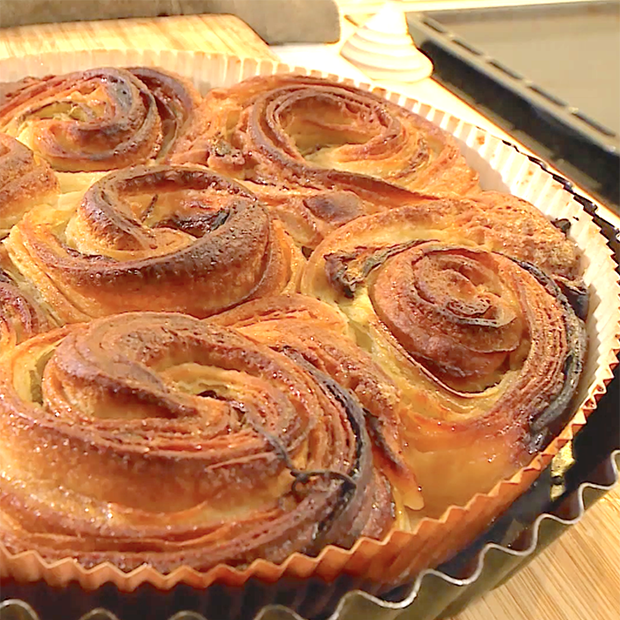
[0,68,587,573]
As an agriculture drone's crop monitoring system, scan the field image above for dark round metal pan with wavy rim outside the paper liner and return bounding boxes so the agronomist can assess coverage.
[0,147,620,620]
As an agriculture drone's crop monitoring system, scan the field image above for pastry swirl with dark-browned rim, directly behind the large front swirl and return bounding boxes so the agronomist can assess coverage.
[5,165,303,324]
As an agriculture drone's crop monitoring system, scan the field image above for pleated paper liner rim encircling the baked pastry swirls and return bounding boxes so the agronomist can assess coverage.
[0,50,620,620]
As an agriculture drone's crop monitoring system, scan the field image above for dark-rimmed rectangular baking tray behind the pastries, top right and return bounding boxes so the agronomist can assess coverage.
[407,0,620,214]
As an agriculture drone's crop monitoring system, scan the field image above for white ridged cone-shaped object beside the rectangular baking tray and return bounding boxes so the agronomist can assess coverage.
[340,2,433,82]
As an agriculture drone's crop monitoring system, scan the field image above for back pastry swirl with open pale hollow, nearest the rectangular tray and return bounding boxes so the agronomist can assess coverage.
[170,75,478,247]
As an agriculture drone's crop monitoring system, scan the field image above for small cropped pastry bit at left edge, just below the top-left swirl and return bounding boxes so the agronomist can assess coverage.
[0,133,59,238]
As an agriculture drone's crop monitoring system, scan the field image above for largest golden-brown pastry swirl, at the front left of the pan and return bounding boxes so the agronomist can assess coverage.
[0,313,393,572]
